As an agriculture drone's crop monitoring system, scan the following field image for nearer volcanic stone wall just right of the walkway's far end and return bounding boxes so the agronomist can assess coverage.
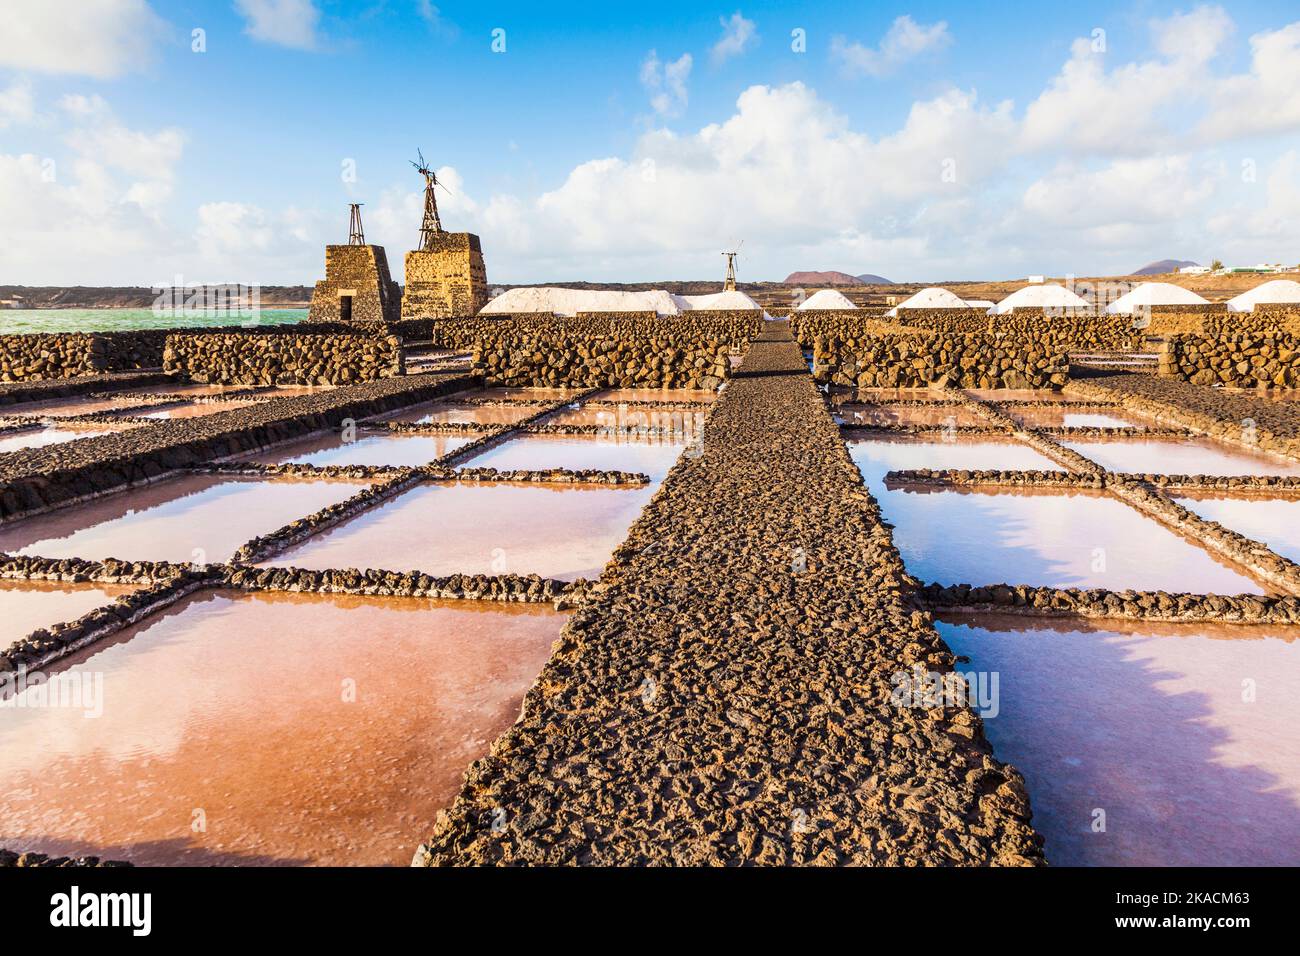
[813,333,1070,389]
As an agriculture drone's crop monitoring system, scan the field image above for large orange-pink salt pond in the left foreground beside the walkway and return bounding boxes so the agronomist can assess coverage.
[0,592,564,865]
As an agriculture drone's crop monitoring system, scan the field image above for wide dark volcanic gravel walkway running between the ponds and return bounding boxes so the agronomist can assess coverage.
[416,323,1043,865]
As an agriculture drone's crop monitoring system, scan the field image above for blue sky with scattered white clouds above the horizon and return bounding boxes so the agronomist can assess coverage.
[0,0,1300,284]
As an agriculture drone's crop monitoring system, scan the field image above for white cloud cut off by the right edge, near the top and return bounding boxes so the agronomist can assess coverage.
[1201,22,1300,138]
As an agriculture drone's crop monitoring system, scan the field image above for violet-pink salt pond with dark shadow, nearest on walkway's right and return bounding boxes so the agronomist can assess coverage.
[939,615,1300,866]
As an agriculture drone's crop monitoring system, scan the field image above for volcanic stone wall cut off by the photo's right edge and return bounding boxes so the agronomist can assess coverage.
[1160,332,1300,389]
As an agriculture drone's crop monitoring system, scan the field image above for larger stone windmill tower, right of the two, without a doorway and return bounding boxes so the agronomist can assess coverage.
[402,232,488,319]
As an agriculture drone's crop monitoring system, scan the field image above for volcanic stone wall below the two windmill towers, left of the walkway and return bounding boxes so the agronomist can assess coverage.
[163,332,403,385]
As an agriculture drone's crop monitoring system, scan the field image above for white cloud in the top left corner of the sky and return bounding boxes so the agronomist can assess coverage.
[0,0,168,78]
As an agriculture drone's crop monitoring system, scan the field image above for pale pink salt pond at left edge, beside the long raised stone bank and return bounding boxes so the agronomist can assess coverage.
[0,475,364,563]
